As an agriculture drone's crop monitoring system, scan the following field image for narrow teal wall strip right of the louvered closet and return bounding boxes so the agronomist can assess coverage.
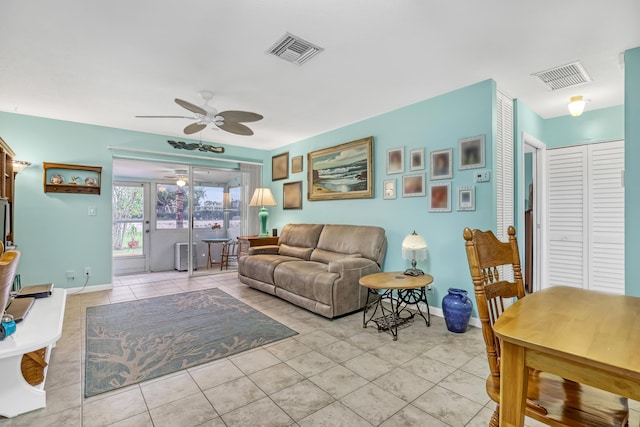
[624,47,640,296]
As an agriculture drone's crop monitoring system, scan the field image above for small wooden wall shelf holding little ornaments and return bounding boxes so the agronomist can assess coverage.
[42,162,102,194]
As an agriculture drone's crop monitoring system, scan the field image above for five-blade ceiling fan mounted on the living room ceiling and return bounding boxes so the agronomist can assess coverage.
[136,90,263,136]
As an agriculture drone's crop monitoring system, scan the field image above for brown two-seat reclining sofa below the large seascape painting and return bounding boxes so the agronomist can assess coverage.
[238,224,387,318]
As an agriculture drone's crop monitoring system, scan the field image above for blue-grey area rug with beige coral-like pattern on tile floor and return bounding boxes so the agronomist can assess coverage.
[85,289,297,397]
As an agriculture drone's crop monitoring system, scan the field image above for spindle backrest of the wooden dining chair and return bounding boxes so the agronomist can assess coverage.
[463,226,525,377]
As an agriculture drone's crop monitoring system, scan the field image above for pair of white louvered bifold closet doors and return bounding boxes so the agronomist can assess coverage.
[545,141,624,294]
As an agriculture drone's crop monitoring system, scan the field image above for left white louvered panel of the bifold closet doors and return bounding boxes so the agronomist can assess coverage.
[543,146,588,288]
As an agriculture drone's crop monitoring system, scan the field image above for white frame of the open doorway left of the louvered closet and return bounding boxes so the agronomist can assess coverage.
[520,132,547,292]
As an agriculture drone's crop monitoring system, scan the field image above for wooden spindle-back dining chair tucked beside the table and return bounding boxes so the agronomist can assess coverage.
[463,227,629,427]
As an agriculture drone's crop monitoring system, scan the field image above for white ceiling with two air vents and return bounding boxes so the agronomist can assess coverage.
[0,0,640,149]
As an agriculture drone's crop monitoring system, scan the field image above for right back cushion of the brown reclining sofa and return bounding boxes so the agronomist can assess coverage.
[311,224,387,266]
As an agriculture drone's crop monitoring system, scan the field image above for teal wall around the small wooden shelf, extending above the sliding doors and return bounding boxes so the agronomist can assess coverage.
[0,112,266,287]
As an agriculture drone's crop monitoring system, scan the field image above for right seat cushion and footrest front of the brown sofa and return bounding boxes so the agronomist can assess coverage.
[273,261,339,305]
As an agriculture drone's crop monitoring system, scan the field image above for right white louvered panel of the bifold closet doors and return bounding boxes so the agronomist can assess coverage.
[589,141,624,295]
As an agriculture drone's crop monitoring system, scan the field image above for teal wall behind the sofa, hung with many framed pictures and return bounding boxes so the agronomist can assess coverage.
[265,80,495,314]
